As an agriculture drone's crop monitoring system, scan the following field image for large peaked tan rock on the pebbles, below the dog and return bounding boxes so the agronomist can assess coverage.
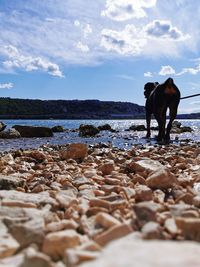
[146,167,177,189]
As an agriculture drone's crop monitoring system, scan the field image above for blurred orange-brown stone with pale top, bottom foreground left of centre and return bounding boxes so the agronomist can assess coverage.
[43,230,81,260]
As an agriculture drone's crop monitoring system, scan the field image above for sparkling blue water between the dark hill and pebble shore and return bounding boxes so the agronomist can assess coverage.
[0,120,200,151]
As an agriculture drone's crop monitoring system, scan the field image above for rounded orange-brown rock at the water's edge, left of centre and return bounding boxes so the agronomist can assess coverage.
[61,144,88,160]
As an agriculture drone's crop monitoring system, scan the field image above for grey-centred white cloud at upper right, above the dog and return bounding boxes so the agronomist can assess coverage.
[145,20,189,40]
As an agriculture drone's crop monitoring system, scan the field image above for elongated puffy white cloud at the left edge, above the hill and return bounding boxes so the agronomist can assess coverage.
[0,45,63,77]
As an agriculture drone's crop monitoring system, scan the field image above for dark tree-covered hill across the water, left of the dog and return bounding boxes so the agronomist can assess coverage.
[0,98,145,119]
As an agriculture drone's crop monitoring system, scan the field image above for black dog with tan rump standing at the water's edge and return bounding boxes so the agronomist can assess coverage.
[144,78,180,141]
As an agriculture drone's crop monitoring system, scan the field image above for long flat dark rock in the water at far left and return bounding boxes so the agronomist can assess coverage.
[13,125,53,137]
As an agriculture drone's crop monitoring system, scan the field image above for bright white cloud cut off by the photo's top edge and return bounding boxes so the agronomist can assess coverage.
[101,0,157,21]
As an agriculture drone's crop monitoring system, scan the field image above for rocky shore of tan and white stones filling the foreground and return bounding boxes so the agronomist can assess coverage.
[0,143,200,267]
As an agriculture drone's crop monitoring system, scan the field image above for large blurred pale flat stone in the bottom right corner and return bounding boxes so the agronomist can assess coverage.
[80,236,200,267]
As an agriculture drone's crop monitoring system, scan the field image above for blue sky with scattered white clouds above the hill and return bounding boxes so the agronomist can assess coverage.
[0,0,200,113]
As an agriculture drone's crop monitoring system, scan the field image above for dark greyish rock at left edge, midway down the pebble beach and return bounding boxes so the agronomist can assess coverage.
[0,174,25,190]
